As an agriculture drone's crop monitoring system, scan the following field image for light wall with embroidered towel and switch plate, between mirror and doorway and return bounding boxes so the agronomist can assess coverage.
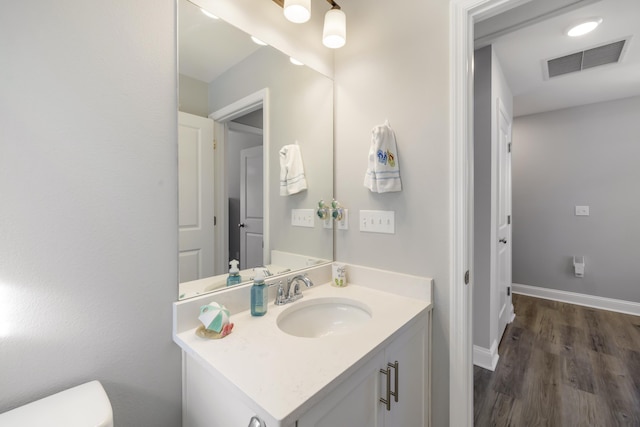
[335,0,449,426]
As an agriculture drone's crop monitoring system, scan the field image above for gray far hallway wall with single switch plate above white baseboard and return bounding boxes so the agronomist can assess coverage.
[513,97,640,302]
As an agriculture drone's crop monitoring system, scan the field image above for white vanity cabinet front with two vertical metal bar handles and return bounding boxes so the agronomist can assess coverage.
[297,312,431,427]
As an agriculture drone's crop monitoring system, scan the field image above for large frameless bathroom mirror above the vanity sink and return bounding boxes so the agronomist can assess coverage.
[178,0,333,299]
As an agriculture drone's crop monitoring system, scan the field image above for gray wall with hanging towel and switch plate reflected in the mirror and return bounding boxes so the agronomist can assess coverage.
[209,48,333,259]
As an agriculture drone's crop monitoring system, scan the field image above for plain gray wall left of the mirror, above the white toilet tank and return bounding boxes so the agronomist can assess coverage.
[0,0,181,427]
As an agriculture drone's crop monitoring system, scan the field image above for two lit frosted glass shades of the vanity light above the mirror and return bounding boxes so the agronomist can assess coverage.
[273,0,347,49]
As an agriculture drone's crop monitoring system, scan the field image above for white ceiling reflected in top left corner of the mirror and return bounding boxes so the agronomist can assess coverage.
[178,0,261,83]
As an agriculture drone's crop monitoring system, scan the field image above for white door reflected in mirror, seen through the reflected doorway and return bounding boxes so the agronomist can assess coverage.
[238,147,264,270]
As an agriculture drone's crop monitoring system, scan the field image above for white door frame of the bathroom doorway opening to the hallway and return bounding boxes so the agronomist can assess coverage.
[449,0,529,427]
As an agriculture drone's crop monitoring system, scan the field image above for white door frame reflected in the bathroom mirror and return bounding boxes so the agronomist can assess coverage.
[209,88,271,274]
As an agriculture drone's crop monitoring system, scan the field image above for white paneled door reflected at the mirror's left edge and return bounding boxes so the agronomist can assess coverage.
[178,112,214,283]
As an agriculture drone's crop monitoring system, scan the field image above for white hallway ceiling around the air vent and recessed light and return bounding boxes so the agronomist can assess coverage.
[476,0,640,116]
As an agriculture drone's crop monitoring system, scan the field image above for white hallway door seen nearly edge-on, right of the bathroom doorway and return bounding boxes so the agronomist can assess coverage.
[495,98,513,342]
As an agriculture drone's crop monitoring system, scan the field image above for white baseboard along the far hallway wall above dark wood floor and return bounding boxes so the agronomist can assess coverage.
[512,283,640,318]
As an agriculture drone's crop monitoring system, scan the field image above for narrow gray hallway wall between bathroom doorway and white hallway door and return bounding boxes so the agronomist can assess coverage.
[473,46,513,349]
